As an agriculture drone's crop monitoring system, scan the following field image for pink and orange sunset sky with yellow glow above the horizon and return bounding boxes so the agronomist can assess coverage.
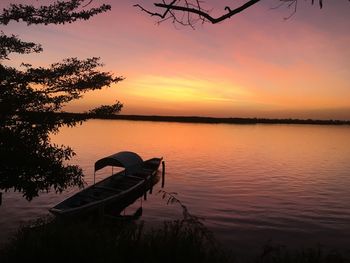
[0,0,350,119]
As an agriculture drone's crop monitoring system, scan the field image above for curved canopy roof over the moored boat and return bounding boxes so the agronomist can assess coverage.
[95,151,143,172]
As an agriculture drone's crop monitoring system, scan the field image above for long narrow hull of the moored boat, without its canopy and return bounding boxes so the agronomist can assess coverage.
[49,158,162,217]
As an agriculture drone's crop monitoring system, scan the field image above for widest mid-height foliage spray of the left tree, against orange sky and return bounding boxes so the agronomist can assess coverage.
[0,58,122,120]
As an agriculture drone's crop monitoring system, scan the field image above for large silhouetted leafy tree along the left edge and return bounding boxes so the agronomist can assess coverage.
[0,0,123,200]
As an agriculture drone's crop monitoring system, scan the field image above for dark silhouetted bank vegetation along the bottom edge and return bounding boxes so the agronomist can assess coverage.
[0,216,350,263]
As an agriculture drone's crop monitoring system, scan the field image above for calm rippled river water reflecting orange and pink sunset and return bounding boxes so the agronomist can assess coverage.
[0,120,350,254]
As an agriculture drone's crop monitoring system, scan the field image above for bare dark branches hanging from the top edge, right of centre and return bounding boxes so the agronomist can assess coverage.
[134,0,350,27]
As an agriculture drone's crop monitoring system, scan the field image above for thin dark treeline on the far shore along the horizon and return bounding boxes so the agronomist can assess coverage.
[55,112,350,125]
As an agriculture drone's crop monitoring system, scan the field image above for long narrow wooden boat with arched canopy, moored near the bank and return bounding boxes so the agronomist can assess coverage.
[49,152,162,216]
